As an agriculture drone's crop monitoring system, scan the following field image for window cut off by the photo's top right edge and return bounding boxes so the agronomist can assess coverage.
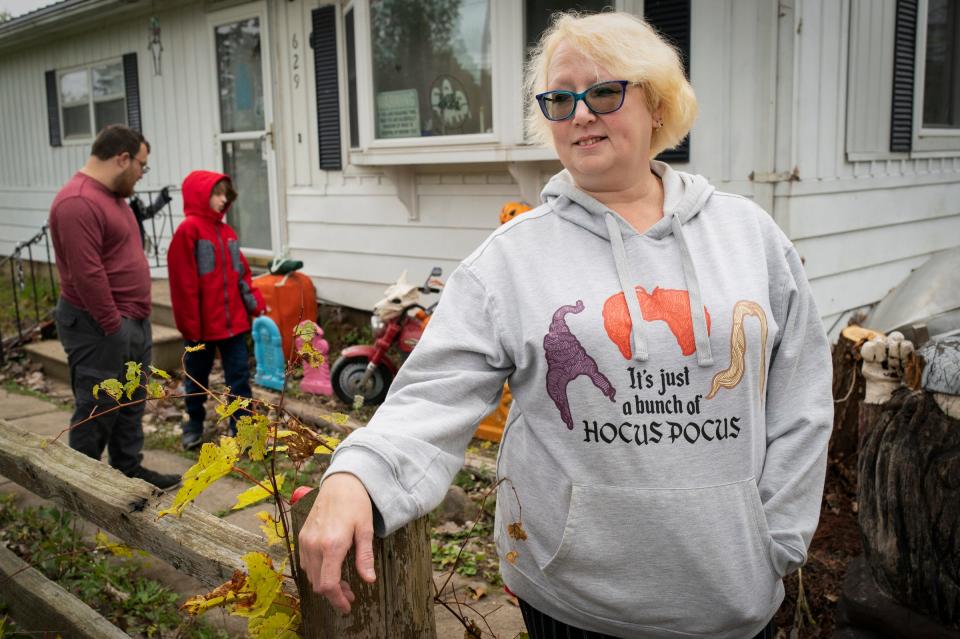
[923,0,960,129]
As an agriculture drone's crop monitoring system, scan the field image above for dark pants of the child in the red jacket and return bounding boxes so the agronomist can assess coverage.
[183,333,253,435]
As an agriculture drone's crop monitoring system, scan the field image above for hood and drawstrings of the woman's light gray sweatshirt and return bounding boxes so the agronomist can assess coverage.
[541,160,714,366]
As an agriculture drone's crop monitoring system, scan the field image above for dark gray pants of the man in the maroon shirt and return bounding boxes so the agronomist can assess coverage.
[54,297,153,475]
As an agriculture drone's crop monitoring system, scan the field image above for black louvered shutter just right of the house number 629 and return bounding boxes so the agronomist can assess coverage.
[310,5,342,171]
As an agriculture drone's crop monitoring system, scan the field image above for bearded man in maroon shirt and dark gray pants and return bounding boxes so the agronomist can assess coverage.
[50,125,180,489]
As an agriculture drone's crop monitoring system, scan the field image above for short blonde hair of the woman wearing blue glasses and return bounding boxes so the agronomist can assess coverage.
[524,11,697,158]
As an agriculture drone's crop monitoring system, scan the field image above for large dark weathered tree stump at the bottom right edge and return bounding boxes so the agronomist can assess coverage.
[858,388,960,628]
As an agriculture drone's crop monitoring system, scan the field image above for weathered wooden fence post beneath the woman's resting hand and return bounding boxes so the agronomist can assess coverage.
[292,489,437,639]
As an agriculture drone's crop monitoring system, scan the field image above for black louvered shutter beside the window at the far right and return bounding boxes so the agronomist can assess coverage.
[890,0,917,151]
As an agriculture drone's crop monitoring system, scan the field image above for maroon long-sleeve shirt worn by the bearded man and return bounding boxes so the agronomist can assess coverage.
[50,173,150,334]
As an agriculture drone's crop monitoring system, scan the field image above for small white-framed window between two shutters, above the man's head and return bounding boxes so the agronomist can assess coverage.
[59,60,127,139]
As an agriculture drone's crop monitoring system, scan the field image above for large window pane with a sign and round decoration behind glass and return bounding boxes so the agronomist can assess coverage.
[370,0,493,139]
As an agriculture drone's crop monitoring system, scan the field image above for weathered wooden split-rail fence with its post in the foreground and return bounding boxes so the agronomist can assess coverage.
[0,419,436,639]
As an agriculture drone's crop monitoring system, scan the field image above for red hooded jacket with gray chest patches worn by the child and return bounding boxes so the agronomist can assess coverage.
[167,171,266,342]
